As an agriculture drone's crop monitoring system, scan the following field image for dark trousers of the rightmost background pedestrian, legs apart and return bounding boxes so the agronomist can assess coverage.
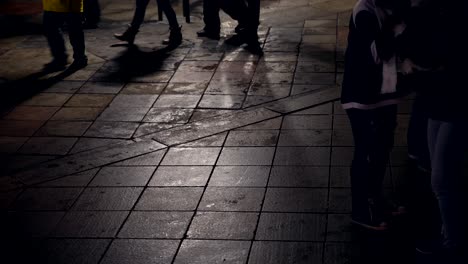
[203,0,247,32]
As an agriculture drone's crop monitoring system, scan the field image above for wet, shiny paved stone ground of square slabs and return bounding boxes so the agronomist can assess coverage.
[0,0,414,264]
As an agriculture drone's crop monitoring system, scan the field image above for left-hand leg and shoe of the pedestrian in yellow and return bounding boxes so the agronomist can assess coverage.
[43,11,67,71]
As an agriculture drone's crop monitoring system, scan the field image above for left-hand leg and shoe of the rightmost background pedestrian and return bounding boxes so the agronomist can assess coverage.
[197,0,221,40]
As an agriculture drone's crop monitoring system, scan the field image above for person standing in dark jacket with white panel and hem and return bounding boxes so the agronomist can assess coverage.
[341,0,409,231]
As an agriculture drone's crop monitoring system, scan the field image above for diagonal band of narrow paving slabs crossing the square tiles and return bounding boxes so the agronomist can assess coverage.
[2,87,340,191]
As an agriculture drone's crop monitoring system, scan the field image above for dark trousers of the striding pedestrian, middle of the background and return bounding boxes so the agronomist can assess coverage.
[131,0,179,29]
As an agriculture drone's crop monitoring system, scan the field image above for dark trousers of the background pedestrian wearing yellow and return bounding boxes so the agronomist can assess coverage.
[44,11,86,60]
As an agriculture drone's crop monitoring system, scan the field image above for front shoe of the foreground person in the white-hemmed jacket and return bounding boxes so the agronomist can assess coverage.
[351,199,388,231]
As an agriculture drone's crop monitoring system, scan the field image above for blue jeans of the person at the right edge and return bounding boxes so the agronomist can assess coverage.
[428,119,468,248]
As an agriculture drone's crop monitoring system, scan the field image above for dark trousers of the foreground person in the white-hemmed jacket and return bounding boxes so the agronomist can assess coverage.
[347,105,397,215]
